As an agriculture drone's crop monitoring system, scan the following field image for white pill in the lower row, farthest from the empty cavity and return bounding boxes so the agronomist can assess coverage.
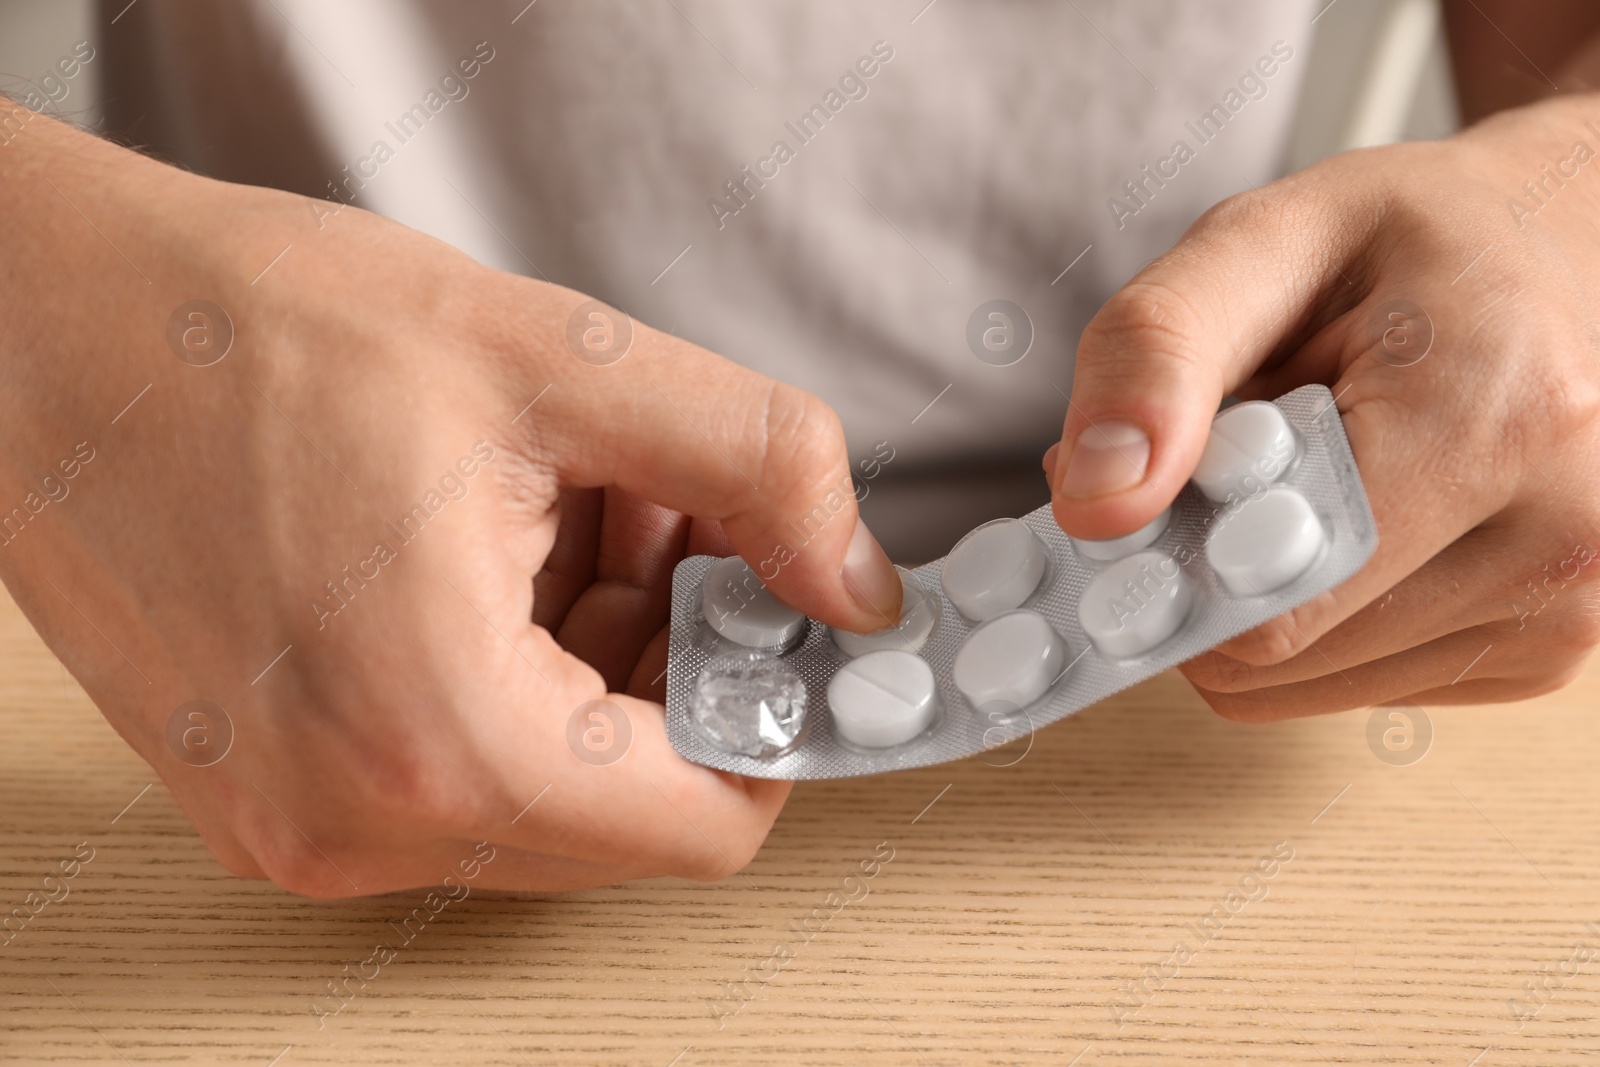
[1205,485,1328,597]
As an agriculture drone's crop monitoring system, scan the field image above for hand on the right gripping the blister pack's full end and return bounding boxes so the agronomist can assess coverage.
[1045,96,1600,720]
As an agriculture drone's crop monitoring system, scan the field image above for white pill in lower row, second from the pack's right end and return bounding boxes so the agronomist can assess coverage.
[1078,549,1195,659]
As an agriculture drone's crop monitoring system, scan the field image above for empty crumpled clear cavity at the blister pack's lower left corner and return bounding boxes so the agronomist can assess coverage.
[690,649,806,758]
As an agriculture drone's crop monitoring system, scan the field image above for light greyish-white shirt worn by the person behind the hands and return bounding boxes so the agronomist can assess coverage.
[102,0,1312,555]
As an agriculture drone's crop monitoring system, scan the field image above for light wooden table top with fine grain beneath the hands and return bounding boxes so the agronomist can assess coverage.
[0,588,1600,1067]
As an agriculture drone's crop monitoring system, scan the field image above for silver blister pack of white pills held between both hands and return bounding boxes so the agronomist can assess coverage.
[667,386,1378,779]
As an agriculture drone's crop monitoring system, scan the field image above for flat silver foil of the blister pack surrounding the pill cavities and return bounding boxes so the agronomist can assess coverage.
[666,386,1378,781]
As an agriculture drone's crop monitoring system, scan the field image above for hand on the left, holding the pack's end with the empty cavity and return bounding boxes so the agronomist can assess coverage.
[0,118,899,896]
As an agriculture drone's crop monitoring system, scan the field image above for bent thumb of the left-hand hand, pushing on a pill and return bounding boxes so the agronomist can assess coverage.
[534,290,901,630]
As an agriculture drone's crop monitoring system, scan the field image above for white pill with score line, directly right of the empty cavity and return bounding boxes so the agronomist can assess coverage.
[827,648,939,749]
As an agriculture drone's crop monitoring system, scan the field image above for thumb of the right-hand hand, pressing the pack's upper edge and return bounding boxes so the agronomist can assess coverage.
[1045,179,1354,539]
